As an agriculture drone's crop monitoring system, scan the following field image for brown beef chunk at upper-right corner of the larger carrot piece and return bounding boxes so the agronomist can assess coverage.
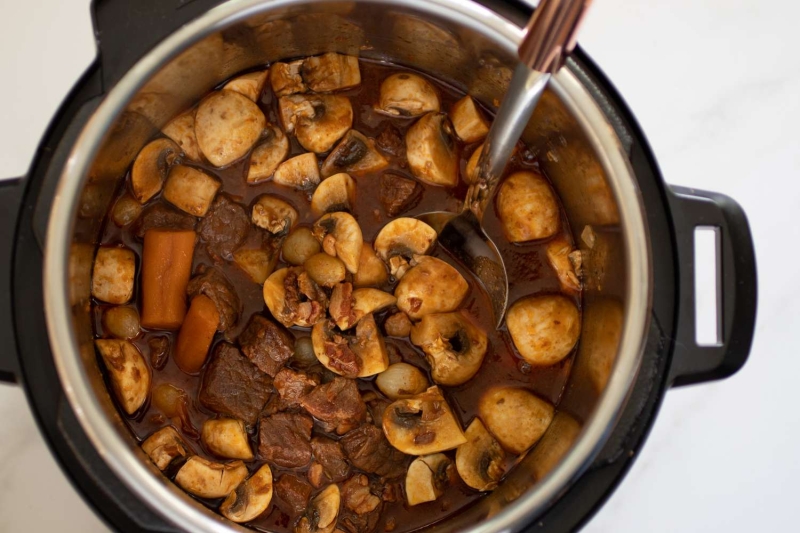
[198,194,250,261]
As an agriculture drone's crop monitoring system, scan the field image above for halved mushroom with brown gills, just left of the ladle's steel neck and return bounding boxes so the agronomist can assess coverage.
[406,113,458,187]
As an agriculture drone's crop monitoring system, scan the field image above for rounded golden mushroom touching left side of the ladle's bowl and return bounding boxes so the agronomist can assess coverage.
[394,255,469,320]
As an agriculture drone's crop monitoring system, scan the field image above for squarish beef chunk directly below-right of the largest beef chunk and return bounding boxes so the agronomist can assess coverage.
[258,413,314,468]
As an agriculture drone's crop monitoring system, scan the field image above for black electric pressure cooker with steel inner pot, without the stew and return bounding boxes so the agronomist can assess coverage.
[0,0,756,532]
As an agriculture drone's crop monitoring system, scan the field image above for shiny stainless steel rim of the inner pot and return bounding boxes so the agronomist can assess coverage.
[44,0,652,533]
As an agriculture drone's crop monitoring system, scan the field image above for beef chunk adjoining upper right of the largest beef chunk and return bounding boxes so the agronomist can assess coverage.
[239,315,294,377]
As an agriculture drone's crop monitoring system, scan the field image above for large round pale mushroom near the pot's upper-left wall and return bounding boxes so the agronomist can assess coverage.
[194,89,267,167]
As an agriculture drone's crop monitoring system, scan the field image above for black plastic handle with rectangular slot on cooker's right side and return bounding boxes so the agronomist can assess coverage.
[670,186,757,386]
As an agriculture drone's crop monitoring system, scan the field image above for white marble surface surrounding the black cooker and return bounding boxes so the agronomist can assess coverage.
[0,0,800,533]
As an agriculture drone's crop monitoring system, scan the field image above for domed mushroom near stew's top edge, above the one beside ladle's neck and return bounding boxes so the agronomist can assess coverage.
[375,72,440,117]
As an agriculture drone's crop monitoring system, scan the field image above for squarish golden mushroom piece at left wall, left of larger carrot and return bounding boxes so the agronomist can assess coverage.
[92,246,136,304]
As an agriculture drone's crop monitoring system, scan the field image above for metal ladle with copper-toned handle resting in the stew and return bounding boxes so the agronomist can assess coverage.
[417,0,590,327]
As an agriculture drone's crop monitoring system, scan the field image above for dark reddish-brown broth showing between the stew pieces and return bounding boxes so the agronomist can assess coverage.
[94,60,580,533]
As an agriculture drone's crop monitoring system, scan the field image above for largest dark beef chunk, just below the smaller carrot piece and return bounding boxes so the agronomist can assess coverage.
[200,343,273,424]
